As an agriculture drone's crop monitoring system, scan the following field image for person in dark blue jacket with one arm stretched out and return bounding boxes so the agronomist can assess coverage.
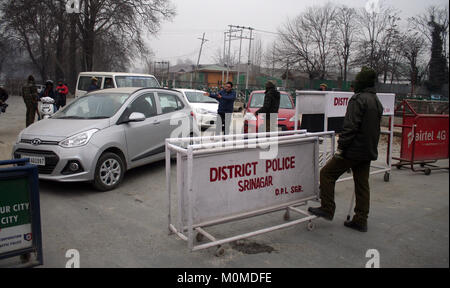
[205,82,236,135]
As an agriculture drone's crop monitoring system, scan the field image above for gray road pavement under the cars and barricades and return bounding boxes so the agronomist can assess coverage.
[0,97,449,268]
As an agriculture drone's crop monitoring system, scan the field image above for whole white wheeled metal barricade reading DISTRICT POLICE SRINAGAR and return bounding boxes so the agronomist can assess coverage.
[166,131,334,256]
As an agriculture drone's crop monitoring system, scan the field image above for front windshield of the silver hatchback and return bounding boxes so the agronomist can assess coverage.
[52,93,130,119]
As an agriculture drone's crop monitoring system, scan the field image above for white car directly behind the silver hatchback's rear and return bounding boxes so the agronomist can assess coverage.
[177,89,219,129]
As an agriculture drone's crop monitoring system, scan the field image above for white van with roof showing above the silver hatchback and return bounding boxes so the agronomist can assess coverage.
[75,72,161,98]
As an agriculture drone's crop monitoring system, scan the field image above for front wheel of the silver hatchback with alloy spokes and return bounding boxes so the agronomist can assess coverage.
[94,153,125,192]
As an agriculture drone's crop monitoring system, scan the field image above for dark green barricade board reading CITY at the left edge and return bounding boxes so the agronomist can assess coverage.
[0,159,43,267]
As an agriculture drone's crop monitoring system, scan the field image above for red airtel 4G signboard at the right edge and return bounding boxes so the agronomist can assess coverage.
[400,115,449,161]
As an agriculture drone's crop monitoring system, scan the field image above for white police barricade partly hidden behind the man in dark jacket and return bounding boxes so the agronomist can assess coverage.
[295,91,395,182]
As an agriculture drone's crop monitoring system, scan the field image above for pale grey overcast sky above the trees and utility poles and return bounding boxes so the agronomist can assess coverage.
[143,0,448,68]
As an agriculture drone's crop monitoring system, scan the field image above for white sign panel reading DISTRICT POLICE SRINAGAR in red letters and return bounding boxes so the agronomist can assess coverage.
[181,139,319,225]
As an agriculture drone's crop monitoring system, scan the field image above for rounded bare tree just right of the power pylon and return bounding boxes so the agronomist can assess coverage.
[277,4,336,79]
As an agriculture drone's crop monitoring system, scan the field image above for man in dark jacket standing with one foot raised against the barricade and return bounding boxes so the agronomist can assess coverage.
[309,67,383,232]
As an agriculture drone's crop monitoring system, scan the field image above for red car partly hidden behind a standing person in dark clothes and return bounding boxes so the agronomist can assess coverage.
[244,91,300,133]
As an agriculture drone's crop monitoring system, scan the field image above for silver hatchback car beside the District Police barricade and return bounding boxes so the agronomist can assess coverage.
[13,88,193,191]
